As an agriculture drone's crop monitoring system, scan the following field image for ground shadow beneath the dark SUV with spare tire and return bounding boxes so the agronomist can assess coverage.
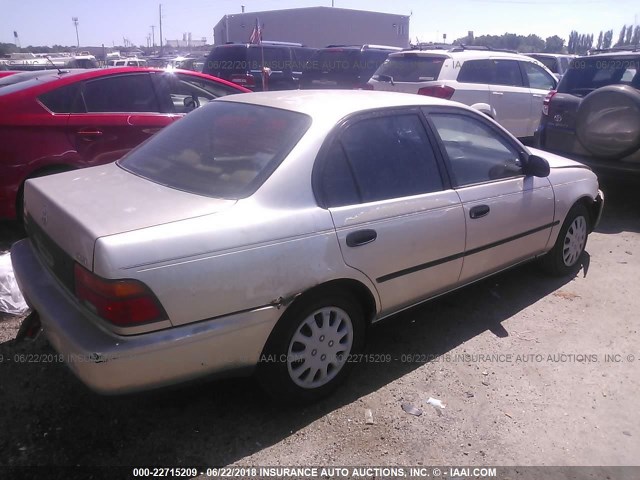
[596,176,640,234]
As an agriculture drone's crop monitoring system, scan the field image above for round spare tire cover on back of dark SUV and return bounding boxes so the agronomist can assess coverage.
[576,85,640,160]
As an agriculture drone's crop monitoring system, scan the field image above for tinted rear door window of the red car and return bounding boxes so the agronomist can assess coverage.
[82,73,160,113]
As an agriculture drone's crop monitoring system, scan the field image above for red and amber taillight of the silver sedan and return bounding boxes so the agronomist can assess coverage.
[74,263,167,327]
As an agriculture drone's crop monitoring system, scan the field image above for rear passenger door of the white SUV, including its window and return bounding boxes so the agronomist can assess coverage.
[489,59,533,137]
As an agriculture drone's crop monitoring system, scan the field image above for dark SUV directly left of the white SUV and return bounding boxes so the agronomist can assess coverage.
[300,45,402,89]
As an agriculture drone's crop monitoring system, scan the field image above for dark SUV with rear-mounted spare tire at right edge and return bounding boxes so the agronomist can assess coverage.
[538,51,640,176]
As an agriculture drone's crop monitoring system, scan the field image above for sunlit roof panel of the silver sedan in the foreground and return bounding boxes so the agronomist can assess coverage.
[216,90,470,123]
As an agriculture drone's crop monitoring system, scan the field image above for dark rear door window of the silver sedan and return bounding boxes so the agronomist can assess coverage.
[321,114,443,207]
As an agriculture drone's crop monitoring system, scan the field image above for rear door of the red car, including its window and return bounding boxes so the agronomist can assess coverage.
[67,72,175,166]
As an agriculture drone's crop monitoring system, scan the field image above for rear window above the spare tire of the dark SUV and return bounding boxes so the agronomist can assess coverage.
[558,56,640,96]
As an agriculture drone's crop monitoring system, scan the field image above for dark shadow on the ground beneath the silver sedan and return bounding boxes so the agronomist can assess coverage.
[0,257,588,466]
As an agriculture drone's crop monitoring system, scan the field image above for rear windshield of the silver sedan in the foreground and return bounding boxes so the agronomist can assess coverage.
[118,101,311,199]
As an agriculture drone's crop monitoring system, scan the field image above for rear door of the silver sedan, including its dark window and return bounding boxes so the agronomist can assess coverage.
[314,110,465,315]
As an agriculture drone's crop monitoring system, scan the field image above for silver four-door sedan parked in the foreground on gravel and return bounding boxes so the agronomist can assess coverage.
[11,91,603,401]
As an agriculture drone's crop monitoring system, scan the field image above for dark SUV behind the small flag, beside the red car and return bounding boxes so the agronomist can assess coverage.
[202,41,315,91]
